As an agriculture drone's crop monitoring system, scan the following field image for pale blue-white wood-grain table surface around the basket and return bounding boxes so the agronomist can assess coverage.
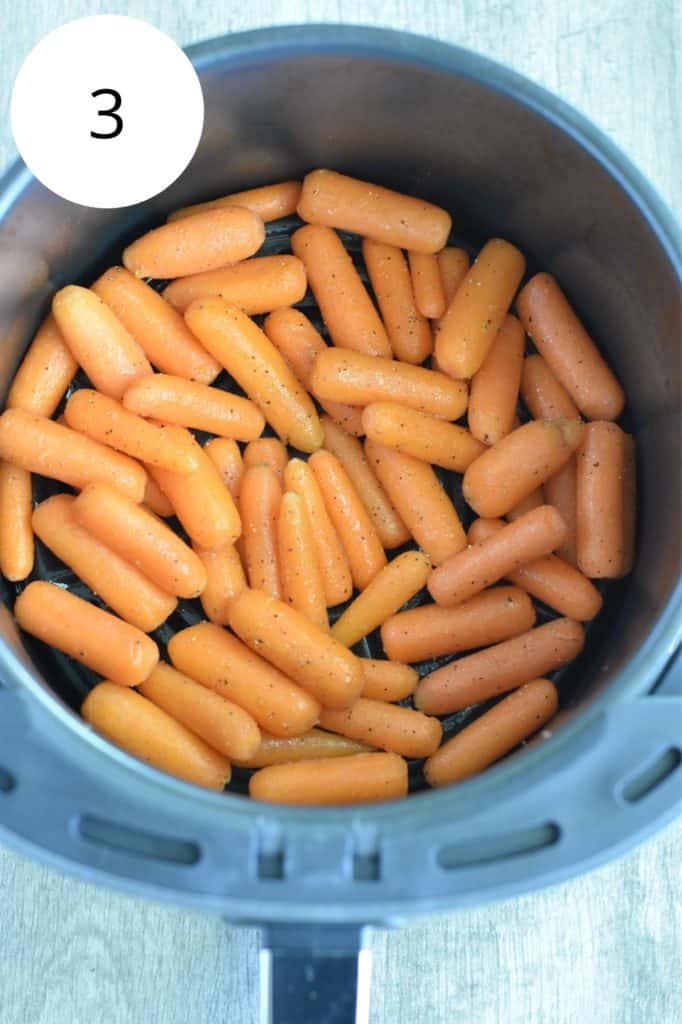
[0,0,682,1024]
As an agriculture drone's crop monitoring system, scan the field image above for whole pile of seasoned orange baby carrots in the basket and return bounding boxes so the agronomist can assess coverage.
[0,170,635,804]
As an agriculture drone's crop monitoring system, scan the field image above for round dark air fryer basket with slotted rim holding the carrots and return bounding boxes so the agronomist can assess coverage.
[0,27,682,1024]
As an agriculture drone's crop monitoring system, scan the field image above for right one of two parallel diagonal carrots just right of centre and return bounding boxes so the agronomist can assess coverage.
[365,439,467,565]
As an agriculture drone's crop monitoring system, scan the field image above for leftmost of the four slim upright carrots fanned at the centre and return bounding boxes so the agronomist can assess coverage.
[240,466,282,597]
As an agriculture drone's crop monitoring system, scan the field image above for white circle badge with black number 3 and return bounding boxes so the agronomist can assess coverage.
[10,14,204,209]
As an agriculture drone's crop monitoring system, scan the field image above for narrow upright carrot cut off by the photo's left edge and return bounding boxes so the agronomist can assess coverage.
[0,462,34,583]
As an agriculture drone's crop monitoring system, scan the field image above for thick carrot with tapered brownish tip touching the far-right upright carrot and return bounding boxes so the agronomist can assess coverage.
[462,420,584,519]
